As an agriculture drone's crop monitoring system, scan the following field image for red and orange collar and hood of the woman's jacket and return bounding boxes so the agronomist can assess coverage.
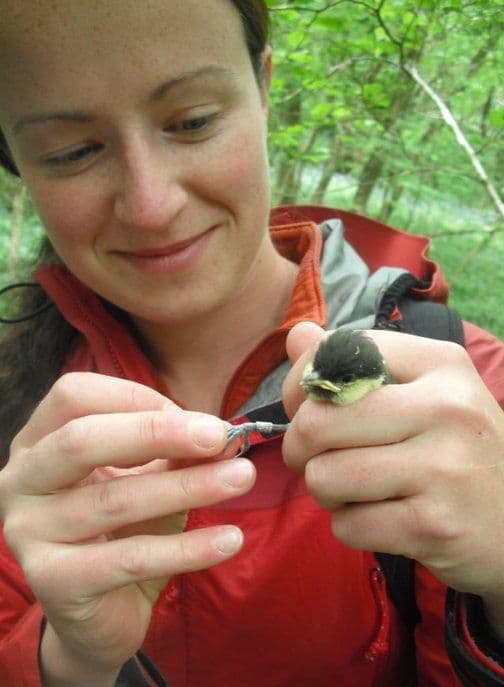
[35,206,447,418]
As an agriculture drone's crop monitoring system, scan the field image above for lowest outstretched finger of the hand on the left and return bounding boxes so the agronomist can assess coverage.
[25,525,243,599]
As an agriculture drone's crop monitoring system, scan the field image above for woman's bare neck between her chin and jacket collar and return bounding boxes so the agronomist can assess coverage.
[132,243,298,414]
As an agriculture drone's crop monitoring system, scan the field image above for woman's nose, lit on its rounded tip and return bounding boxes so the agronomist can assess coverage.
[114,148,188,232]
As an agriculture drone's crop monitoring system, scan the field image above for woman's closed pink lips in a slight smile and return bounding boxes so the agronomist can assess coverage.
[116,227,216,274]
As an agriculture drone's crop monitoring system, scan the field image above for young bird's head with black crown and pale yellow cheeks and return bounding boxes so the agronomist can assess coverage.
[300,329,393,405]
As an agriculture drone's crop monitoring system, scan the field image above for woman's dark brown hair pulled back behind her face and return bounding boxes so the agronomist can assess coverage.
[0,0,269,467]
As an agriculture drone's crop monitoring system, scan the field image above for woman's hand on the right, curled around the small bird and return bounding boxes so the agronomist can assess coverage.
[283,324,504,635]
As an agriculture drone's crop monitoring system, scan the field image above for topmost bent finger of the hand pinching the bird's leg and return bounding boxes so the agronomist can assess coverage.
[13,372,175,448]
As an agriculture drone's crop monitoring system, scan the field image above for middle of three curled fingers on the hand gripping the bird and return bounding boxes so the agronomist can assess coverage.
[305,442,429,510]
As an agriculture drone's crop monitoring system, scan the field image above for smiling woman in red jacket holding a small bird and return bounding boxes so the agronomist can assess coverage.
[0,0,504,687]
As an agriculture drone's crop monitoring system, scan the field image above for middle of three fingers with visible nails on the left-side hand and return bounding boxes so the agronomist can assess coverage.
[21,458,255,543]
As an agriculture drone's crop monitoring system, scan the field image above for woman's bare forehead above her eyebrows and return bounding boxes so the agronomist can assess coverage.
[0,0,249,118]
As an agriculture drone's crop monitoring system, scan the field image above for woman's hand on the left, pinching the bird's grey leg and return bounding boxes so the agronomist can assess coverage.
[0,373,255,685]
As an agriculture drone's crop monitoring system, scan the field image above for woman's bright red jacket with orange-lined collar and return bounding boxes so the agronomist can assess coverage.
[0,208,504,687]
